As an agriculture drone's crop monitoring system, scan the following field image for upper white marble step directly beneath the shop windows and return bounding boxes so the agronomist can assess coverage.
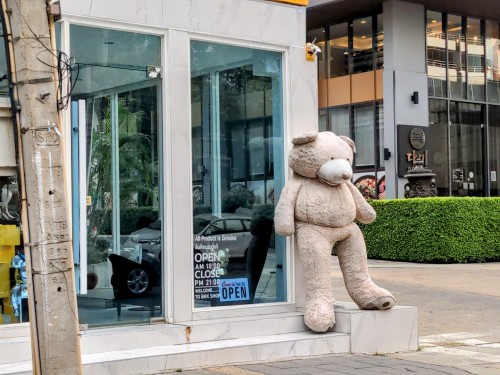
[0,312,307,364]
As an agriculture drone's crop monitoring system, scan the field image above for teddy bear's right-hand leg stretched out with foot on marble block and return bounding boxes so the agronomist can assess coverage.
[336,223,396,310]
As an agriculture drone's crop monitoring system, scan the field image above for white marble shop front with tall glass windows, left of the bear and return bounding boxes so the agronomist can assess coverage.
[0,0,332,374]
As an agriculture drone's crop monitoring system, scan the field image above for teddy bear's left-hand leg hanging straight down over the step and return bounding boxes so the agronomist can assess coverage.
[295,224,335,332]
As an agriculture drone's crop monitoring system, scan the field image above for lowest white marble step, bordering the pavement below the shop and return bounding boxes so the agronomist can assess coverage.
[0,331,350,375]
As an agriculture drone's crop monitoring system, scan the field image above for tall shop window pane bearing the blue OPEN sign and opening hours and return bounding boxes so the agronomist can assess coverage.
[191,41,287,308]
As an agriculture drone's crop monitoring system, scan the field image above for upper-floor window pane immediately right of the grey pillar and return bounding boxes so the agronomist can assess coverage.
[427,11,446,97]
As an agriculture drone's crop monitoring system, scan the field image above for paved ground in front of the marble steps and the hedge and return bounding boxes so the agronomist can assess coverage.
[156,257,500,375]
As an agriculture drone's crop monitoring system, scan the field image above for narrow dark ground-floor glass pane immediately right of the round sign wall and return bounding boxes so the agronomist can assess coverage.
[426,99,450,196]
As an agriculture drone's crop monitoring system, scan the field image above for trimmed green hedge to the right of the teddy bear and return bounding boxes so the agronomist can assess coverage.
[360,198,500,263]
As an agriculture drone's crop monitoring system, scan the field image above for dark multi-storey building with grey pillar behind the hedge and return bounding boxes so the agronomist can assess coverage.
[307,0,500,198]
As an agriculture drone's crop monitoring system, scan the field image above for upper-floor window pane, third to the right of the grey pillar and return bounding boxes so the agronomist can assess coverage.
[467,18,485,101]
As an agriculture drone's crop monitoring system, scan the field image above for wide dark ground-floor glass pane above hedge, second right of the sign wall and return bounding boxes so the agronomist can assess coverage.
[450,102,484,196]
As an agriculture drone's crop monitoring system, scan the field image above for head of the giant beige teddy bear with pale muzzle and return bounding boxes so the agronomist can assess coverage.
[288,131,356,186]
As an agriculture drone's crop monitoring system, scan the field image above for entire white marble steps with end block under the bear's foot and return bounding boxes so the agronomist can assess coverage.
[0,303,418,375]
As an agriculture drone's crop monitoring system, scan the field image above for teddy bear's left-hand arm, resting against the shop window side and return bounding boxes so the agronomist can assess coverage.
[274,175,302,236]
